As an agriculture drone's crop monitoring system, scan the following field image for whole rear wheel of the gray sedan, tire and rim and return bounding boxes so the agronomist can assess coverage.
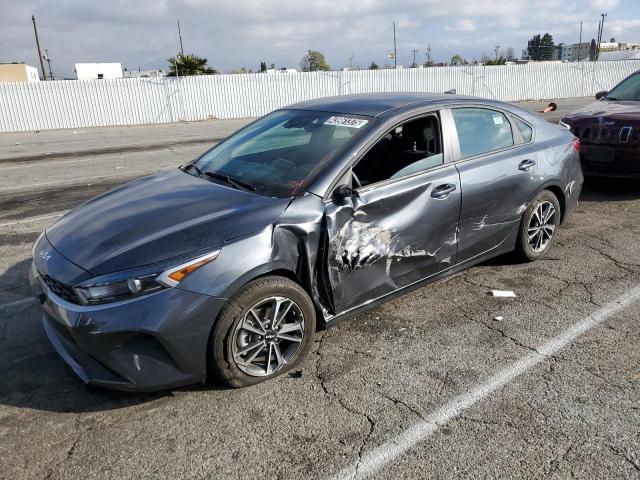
[515,190,561,262]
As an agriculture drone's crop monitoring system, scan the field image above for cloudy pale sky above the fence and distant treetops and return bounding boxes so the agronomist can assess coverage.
[0,0,640,78]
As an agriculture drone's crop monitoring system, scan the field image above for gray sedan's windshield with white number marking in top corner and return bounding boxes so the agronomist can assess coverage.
[193,110,373,197]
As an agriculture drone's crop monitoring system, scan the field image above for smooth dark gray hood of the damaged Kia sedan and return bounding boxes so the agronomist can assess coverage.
[46,169,289,275]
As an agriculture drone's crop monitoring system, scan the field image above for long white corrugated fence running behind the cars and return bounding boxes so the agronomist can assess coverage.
[0,60,640,132]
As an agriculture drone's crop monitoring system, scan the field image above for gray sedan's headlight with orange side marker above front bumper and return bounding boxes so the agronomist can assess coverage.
[74,250,220,305]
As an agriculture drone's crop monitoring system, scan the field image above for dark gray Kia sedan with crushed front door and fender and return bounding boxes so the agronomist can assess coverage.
[30,94,583,390]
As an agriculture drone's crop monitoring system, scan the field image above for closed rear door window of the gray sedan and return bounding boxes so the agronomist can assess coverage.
[451,108,513,158]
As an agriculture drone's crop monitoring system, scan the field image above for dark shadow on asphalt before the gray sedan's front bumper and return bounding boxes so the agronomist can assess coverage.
[0,260,180,413]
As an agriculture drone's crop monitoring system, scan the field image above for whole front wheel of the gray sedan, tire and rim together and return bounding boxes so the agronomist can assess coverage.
[208,276,316,388]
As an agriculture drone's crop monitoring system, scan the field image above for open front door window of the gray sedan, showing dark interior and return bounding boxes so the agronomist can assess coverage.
[353,114,444,186]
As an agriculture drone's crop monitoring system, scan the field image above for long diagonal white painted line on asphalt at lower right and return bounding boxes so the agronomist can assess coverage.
[332,285,640,480]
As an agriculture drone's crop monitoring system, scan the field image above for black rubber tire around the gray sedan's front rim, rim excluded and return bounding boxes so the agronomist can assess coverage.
[208,276,316,388]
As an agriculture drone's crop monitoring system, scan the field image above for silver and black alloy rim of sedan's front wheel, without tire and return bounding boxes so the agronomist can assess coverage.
[232,296,305,377]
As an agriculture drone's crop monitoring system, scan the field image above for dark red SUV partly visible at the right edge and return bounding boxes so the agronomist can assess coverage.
[560,71,640,177]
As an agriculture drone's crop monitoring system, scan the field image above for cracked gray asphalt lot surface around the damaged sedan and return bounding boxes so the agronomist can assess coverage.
[0,98,640,479]
